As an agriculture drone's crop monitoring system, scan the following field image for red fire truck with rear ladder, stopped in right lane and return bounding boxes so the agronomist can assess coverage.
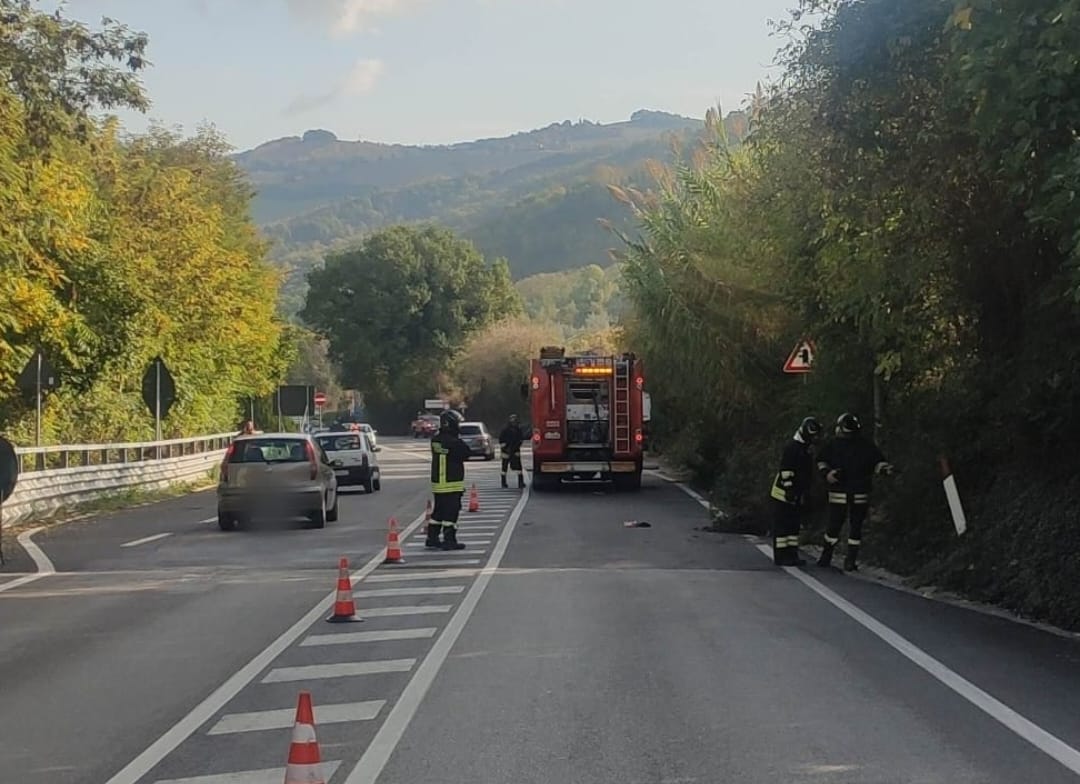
[522,347,646,491]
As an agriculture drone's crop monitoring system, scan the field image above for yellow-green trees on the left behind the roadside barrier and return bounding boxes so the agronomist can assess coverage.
[0,2,288,443]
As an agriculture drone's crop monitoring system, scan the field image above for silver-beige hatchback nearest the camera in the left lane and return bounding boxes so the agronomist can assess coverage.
[217,433,338,531]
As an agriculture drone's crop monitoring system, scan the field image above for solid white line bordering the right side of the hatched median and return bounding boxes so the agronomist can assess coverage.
[340,481,529,784]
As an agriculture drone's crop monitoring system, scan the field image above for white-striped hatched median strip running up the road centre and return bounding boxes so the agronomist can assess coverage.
[123,442,528,784]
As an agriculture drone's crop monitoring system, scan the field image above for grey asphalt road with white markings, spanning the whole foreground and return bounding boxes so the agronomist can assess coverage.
[0,440,1080,784]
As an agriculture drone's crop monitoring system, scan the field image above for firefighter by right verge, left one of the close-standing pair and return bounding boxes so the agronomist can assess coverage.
[770,417,821,566]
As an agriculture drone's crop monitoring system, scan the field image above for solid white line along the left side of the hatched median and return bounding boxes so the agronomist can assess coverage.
[105,515,423,784]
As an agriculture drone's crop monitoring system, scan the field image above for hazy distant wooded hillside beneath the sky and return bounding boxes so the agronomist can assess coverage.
[235,110,746,312]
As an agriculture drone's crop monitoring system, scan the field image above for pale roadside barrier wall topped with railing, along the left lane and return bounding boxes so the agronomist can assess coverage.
[3,433,234,524]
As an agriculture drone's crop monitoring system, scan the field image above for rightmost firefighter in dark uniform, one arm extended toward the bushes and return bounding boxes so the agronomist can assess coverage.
[818,414,892,571]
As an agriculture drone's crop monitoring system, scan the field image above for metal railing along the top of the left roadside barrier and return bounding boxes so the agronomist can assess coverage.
[15,433,235,472]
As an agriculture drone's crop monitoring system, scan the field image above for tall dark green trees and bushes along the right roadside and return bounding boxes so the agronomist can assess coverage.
[616,0,1080,624]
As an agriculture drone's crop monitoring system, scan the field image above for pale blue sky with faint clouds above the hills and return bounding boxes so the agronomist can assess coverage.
[54,0,795,149]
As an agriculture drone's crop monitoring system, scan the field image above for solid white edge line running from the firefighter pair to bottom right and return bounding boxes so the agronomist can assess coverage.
[756,544,1080,773]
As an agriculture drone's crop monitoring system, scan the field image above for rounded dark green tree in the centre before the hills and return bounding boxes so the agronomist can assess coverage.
[301,226,521,427]
